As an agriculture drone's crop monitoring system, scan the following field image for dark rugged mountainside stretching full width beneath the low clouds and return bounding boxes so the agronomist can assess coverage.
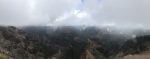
[0,26,150,59]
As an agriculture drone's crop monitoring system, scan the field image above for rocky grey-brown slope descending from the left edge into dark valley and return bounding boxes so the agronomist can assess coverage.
[0,26,58,59]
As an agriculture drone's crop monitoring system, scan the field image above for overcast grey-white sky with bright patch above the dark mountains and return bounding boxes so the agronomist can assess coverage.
[0,0,150,27]
